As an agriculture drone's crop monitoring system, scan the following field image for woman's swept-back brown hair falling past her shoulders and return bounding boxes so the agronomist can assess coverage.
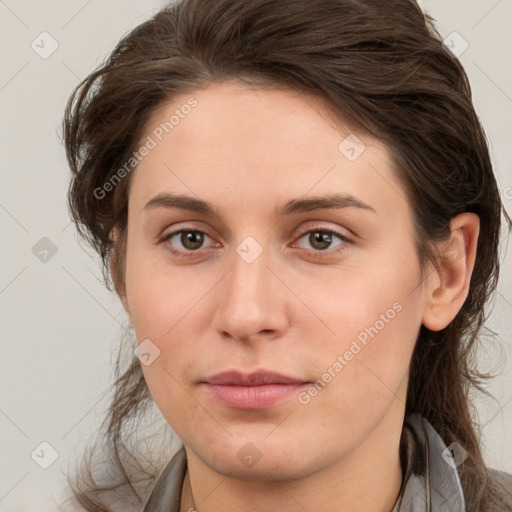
[63,0,512,512]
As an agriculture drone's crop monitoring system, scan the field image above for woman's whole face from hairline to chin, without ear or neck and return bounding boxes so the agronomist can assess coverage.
[126,83,424,479]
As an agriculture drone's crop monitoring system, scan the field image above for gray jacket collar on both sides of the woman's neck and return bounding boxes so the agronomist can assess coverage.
[143,414,512,512]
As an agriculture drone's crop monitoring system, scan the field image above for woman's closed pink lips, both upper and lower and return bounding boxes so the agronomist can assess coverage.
[201,370,310,409]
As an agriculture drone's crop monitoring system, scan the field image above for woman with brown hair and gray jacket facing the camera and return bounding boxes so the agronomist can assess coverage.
[64,0,512,512]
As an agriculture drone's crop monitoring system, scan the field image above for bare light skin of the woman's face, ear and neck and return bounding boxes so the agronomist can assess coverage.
[112,83,479,512]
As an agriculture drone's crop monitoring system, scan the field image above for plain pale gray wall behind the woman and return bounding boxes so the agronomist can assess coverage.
[0,0,512,512]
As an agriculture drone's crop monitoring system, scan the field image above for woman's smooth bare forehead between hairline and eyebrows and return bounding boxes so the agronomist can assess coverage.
[130,83,406,220]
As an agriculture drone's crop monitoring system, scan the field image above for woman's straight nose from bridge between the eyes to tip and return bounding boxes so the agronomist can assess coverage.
[212,237,286,339]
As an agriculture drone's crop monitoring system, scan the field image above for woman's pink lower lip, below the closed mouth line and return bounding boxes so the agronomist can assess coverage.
[206,383,308,409]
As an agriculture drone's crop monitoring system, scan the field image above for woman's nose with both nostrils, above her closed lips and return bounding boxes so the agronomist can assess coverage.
[213,242,293,343]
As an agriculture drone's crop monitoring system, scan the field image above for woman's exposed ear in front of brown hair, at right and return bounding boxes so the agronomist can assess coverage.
[422,213,480,331]
